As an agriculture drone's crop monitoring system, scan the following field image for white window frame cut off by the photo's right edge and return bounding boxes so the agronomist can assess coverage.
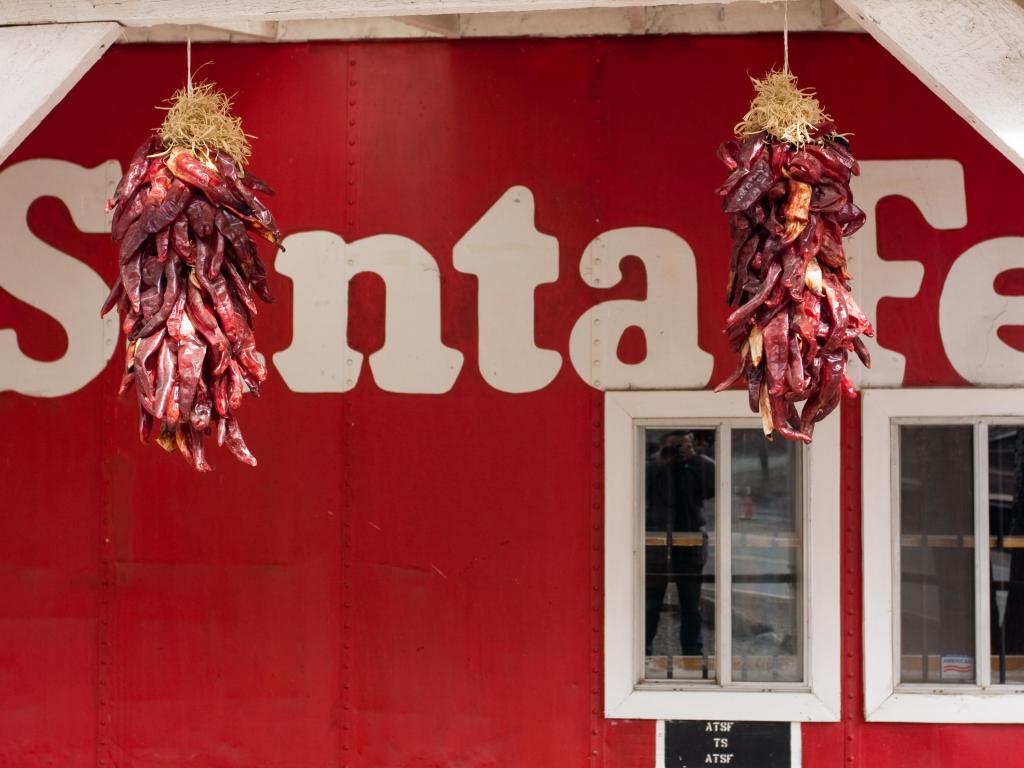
[862,389,1024,723]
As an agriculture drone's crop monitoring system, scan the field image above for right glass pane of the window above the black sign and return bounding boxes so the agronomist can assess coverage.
[731,429,804,682]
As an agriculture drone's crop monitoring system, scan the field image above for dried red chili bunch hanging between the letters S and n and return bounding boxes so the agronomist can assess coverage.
[101,83,281,472]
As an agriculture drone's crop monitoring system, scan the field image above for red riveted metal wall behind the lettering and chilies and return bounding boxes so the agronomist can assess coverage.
[0,36,1024,768]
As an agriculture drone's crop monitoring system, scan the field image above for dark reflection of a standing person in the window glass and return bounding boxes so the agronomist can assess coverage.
[644,432,715,655]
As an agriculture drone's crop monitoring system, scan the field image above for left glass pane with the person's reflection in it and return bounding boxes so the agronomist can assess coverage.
[644,428,716,681]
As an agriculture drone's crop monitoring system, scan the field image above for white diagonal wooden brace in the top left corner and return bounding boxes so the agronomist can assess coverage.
[0,23,121,163]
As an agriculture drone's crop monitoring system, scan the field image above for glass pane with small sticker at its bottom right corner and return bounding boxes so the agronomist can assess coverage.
[897,425,977,685]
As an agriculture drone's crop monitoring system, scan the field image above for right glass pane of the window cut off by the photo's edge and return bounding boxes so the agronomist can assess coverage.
[988,424,1024,685]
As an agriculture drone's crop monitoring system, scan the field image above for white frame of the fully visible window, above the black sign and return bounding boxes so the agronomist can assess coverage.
[604,391,840,722]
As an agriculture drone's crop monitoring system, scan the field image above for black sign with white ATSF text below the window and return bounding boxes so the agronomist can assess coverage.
[665,720,792,768]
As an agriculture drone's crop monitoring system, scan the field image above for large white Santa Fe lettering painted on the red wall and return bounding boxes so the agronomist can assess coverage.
[0,165,999,399]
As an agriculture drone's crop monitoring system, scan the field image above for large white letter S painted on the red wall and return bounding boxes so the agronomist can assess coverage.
[0,160,121,397]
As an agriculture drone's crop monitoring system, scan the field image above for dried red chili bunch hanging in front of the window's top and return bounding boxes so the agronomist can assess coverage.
[716,72,873,442]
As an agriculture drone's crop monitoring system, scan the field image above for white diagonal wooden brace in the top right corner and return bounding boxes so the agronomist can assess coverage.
[837,0,1024,171]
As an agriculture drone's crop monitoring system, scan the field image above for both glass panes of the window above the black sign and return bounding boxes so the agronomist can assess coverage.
[644,427,804,682]
